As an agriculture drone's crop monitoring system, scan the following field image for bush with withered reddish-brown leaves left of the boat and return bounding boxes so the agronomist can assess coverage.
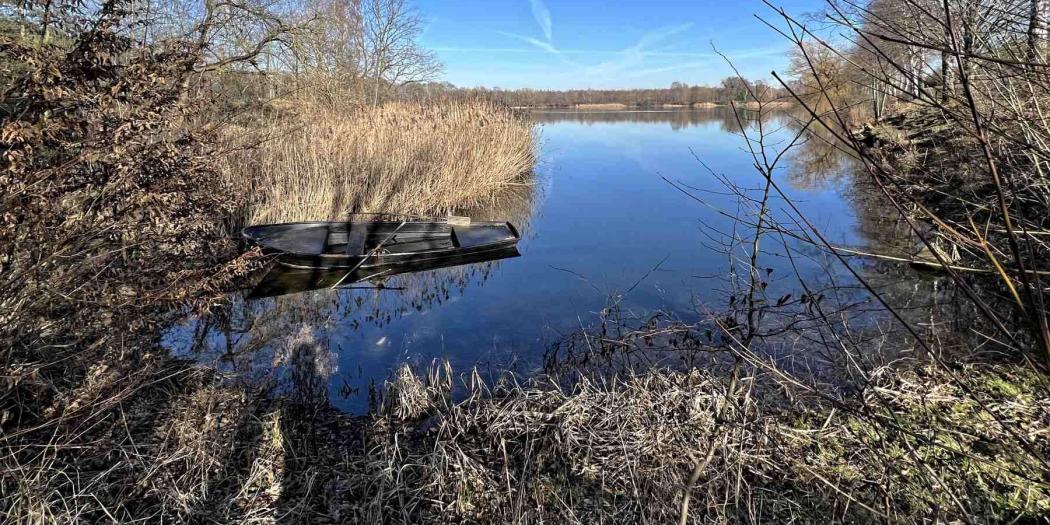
[0,1,241,405]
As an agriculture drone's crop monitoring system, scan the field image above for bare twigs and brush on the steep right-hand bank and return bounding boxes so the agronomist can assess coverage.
[776,0,1050,366]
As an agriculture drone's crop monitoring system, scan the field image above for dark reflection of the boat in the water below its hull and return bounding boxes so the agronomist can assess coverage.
[247,246,521,299]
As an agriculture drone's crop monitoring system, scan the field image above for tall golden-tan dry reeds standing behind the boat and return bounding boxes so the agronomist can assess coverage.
[224,102,536,224]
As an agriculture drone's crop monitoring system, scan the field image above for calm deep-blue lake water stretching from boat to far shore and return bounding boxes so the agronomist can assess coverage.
[165,109,865,412]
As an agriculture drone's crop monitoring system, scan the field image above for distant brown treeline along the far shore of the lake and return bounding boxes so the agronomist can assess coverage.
[401,77,789,107]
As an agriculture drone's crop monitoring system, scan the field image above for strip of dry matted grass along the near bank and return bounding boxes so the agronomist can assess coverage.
[339,359,1050,523]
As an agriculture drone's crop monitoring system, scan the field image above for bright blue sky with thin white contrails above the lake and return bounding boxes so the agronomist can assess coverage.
[415,0,822,89]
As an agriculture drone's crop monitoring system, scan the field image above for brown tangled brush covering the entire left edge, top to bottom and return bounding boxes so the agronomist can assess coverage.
[0,2,273,523]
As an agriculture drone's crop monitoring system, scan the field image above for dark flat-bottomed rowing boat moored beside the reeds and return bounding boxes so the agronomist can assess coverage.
[242,221,521,270]
